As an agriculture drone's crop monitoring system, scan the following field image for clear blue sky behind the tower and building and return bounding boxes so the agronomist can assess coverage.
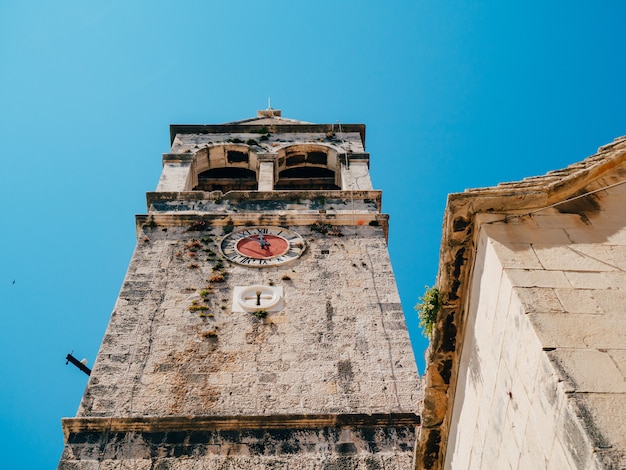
[0,0,626,469]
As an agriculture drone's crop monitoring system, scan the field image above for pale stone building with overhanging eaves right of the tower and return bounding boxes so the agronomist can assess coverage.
[415,137,626,470]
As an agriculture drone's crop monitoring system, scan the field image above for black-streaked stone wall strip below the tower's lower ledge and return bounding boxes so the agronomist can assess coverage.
[60,420,415,470]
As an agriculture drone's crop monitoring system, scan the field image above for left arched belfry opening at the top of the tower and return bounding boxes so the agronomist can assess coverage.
[193,144,257,193]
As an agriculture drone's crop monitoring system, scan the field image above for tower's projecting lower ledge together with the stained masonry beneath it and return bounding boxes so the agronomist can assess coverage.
[61,415,415,470]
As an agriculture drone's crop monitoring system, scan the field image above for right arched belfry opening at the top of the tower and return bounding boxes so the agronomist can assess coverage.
[274,144,341,191]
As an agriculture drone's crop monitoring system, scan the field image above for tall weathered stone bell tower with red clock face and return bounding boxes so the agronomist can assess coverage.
[59,109,422,469]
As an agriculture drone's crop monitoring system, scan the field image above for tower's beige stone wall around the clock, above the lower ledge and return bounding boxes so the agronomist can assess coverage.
[79,227,419,416]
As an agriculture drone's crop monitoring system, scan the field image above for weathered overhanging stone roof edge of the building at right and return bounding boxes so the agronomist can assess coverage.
[415,136,626,469]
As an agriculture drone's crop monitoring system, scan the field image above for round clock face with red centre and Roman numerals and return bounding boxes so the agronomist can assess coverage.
[220,226,305,268]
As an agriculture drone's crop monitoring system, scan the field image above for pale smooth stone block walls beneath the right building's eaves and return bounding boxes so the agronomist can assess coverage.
[446,185,626,469]
